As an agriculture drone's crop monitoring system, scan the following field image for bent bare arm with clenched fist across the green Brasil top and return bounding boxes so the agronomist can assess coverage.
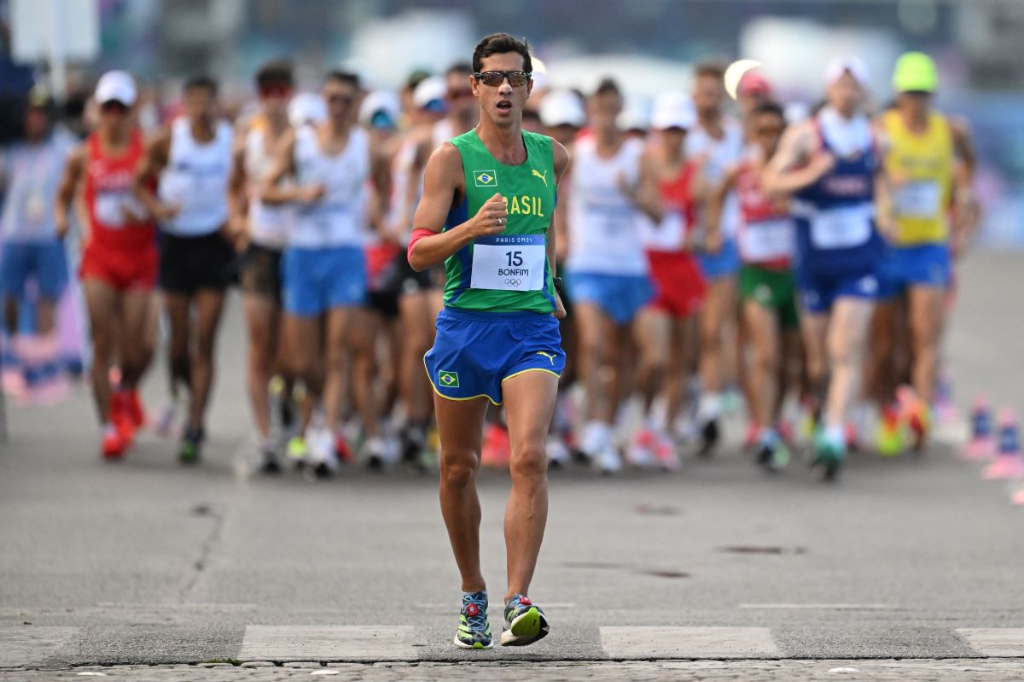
[409,142,508,271]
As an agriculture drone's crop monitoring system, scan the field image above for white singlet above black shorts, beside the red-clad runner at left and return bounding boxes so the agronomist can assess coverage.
[158,117,233,237]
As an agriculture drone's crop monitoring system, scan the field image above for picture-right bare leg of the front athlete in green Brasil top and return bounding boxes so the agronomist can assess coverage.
[502,372,558,603]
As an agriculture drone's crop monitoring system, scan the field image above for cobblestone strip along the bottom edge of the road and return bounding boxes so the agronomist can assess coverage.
[6,658,1024,682]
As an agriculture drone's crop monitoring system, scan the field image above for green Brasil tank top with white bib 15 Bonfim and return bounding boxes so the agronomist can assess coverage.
[444,130,556,313]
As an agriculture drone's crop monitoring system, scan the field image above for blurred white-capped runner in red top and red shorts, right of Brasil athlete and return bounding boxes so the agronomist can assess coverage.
[631,92,707,469]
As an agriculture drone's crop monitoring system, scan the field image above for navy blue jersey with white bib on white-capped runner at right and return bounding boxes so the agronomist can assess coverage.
[795,119,883,275]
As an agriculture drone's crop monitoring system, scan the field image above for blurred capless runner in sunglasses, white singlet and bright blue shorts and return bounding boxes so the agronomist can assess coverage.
[261,72,383,475]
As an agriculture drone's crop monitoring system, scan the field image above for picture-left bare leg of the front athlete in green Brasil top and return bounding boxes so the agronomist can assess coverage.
[434,393,489,592]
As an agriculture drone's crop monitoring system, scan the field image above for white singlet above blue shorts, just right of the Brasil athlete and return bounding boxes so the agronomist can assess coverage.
[566,137,648,275]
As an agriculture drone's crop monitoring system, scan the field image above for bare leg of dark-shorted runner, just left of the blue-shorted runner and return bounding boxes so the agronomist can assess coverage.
[243,294,281,439]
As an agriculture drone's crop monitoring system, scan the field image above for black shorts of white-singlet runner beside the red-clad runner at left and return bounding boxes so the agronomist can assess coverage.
[160,230,237,294]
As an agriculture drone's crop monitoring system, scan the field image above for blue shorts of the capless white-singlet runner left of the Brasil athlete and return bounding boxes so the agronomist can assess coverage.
[281,247,367,317]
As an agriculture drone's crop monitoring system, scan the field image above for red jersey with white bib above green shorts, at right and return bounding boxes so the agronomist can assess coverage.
[736,161,796,269]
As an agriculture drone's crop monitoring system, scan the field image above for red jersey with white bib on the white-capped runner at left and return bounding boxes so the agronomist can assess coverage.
[85,130,157,250]
